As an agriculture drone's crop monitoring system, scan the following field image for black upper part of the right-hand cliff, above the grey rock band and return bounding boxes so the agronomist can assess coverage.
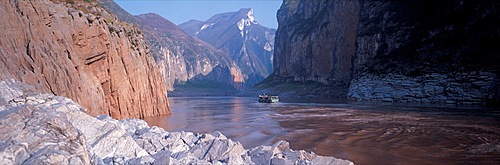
[353,0,500,75]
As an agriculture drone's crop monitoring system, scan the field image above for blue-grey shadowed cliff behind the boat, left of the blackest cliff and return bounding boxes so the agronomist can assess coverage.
[274,0,360,84]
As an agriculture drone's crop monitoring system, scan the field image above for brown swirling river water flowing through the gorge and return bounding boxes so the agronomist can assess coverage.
[145,97,500,165]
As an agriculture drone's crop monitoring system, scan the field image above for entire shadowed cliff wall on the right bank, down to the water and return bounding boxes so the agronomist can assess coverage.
[274,0,500,104]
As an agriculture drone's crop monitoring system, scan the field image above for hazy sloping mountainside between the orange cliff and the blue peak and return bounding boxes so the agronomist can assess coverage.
[98,0,244,90]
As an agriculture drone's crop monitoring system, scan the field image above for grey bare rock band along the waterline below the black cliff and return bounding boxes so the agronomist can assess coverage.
[348,72,500,104]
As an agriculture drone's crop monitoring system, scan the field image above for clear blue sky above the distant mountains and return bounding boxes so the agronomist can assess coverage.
[115,0,282,28]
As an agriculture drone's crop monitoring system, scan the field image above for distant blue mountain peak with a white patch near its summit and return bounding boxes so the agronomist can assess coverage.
[179,8,276,86]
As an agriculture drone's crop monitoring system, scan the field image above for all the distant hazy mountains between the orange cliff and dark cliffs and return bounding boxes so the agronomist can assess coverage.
[99,0,276,94]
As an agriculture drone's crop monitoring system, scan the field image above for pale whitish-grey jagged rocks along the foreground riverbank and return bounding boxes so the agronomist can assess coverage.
[0,81,353,164]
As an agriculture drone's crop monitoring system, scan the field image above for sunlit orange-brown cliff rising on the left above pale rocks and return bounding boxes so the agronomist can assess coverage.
[0,0,170,118]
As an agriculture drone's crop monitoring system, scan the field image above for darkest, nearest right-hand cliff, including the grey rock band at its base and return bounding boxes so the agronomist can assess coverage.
[348,0,500,104]
